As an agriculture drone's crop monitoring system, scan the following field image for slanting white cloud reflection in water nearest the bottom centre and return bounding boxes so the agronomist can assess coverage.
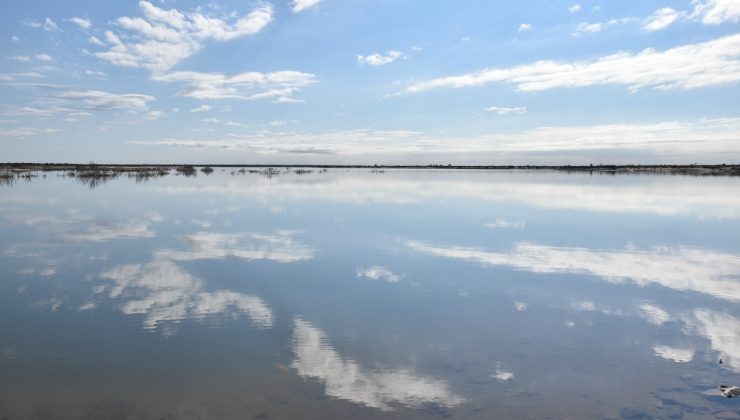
[291,319,464,411]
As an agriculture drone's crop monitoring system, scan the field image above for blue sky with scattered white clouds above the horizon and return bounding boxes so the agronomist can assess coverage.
[0,0,740,164]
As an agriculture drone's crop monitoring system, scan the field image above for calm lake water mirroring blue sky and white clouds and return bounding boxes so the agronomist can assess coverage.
[0,169,740,419]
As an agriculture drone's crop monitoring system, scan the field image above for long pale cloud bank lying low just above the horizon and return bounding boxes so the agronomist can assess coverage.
[133,118,740,164]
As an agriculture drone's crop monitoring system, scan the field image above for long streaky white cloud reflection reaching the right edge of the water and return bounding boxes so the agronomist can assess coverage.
[407,241,740,302]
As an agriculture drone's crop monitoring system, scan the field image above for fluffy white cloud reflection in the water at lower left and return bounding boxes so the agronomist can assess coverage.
[100,260,273,329]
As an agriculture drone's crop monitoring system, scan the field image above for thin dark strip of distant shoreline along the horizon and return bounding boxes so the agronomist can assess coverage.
[0,162,740,176]
